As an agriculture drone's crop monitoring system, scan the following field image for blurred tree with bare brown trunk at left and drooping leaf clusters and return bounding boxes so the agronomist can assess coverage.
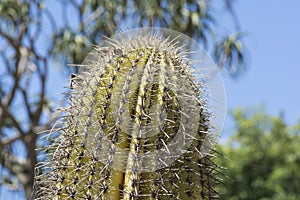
[0,0,245,199]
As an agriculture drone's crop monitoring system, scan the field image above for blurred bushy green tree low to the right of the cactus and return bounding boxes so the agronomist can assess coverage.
[219,109,300,200]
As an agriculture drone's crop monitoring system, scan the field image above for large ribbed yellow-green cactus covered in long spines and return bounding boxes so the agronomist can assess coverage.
[34,28,225,200]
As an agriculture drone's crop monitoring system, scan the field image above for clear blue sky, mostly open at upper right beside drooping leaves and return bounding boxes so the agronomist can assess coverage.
[0,0,300,199]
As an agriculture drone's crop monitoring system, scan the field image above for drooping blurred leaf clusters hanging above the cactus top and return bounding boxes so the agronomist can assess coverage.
[53,0,246,77]
